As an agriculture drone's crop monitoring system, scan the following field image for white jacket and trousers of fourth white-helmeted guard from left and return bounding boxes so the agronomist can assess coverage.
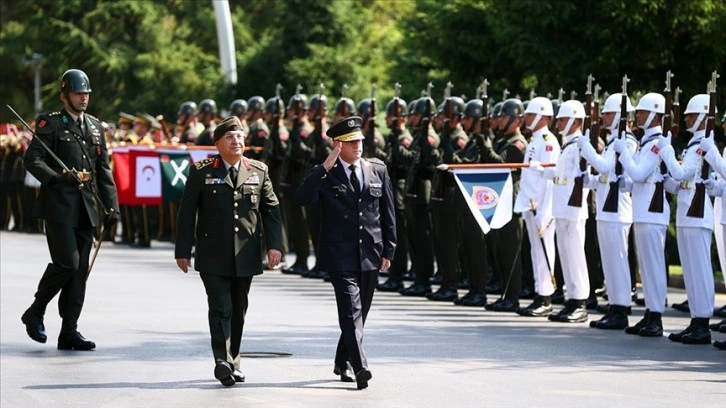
[620,126,671,313]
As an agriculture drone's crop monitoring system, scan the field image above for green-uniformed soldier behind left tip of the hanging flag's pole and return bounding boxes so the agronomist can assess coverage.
[427,94,469,302]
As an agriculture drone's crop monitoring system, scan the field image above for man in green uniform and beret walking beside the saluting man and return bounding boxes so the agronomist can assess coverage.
[174,116,282,386]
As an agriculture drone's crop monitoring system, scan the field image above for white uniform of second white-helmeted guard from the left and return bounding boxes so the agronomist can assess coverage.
[544,130,590,300]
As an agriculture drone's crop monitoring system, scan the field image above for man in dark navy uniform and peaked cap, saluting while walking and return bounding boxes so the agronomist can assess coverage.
[297,116,396,389]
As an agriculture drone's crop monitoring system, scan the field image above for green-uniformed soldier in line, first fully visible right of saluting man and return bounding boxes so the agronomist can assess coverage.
[377,97,413,292]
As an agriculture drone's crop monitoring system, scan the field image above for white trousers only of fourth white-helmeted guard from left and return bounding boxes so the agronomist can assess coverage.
[633,222,668,313]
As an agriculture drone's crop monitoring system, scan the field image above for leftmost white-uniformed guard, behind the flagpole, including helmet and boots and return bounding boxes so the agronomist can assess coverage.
[514,97,560,316]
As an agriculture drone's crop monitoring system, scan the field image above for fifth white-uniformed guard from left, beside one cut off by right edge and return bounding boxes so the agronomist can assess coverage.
[658,94,715,344]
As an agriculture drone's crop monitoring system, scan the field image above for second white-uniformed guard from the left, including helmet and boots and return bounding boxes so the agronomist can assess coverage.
[538,100,590,323]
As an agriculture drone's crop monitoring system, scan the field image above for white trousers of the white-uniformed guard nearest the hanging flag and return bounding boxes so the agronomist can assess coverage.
[522,211,555,296]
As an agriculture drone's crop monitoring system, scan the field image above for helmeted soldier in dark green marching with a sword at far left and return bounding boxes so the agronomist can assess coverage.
[22,69,118,350]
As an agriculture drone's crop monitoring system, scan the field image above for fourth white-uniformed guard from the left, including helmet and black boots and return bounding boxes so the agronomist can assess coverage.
[613,93,670,337]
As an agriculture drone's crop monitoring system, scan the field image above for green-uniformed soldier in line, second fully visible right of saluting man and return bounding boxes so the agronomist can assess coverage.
[399,96,441,296]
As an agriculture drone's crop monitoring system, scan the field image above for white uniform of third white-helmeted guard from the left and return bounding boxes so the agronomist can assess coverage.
[581,132,638,306]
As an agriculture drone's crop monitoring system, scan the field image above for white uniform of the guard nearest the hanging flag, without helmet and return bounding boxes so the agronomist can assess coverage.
[514,126,560,296]
